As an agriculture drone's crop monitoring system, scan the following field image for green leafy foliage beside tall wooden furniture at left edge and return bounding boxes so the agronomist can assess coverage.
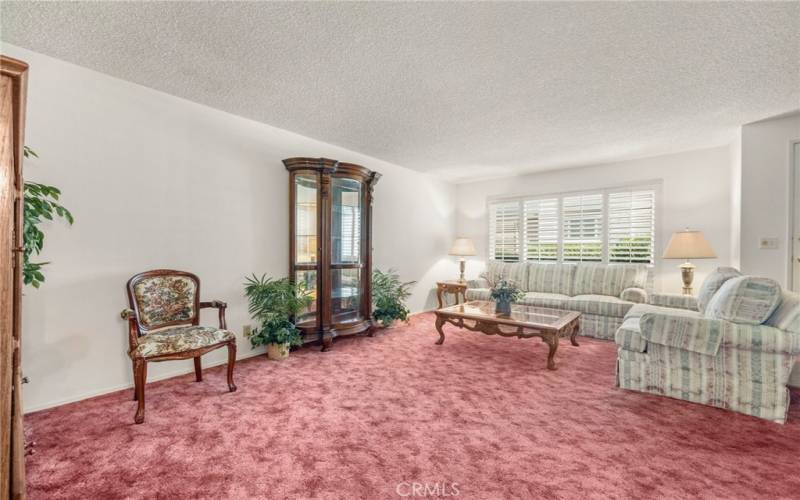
[22,146,74,288]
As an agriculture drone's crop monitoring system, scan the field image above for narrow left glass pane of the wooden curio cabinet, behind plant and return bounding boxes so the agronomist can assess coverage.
[292,173,319,326]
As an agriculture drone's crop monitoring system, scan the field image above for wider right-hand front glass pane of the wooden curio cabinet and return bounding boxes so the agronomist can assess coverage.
[331,177,363,323]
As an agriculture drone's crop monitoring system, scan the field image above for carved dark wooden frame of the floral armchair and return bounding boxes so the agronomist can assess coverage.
[121,269,236,424]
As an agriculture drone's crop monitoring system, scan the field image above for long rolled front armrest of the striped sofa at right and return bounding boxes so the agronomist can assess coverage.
[639,313,800,356]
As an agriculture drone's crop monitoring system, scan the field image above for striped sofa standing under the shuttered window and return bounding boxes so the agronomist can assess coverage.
[466,261,653,339]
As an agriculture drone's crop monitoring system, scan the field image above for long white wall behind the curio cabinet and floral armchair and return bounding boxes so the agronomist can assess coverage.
[2,44,457,411]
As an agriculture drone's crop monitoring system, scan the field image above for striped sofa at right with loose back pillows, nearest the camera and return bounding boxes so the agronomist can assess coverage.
[615,268,800,423]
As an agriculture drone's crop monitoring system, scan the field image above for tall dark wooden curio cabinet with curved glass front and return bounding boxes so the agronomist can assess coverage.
[283,158,380,350]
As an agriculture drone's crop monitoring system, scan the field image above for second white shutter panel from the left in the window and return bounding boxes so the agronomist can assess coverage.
[522,198,558,262]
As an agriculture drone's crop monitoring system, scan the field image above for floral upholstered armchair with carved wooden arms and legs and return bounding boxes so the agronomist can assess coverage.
[121,269,236,424]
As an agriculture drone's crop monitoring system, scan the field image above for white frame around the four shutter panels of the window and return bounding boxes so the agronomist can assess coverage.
[486,183,663,276]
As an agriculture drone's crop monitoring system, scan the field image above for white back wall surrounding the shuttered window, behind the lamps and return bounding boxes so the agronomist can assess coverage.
[457,146,733,293]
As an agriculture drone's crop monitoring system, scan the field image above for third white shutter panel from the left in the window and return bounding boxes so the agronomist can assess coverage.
[561,193,603,262]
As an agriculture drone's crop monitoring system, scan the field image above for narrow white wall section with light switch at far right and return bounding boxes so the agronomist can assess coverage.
[741,113,800,287]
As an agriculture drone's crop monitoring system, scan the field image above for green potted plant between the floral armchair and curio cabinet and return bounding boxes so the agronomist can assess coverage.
[244,274,312,360]
